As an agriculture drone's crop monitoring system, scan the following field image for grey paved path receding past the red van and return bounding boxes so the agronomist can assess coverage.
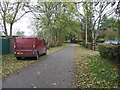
[2,44,75,88]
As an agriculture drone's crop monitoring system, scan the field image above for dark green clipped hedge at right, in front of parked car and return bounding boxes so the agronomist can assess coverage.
[98,44,120,59]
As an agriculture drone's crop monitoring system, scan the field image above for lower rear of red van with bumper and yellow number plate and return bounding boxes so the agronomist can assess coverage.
[14,50,37,57]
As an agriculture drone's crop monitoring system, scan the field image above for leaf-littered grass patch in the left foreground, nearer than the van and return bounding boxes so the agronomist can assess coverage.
[2,54,35,78]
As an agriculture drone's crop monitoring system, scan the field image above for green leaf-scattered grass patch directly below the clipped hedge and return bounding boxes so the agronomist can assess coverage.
[86,55,120,88]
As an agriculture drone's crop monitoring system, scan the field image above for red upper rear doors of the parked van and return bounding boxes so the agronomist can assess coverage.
[16,37,35,50]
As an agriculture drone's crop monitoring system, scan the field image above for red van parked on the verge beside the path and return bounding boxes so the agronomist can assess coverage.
[14,37,47,60]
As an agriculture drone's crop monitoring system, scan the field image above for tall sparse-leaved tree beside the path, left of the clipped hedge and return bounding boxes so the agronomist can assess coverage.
[80,2,115,49]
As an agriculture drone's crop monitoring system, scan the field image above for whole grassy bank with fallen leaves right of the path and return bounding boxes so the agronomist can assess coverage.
[75,46,120,88]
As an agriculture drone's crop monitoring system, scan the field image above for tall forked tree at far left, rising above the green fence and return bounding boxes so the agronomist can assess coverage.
[0,0,30,37]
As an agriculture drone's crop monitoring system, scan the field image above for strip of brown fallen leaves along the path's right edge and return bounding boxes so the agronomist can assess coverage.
[74,47,98,88]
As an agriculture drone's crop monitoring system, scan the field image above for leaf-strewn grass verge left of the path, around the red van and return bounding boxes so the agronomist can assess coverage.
[0,45,66,78]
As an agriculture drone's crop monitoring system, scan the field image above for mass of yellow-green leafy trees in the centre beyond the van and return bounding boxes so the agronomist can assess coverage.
[34,2,79,46]
